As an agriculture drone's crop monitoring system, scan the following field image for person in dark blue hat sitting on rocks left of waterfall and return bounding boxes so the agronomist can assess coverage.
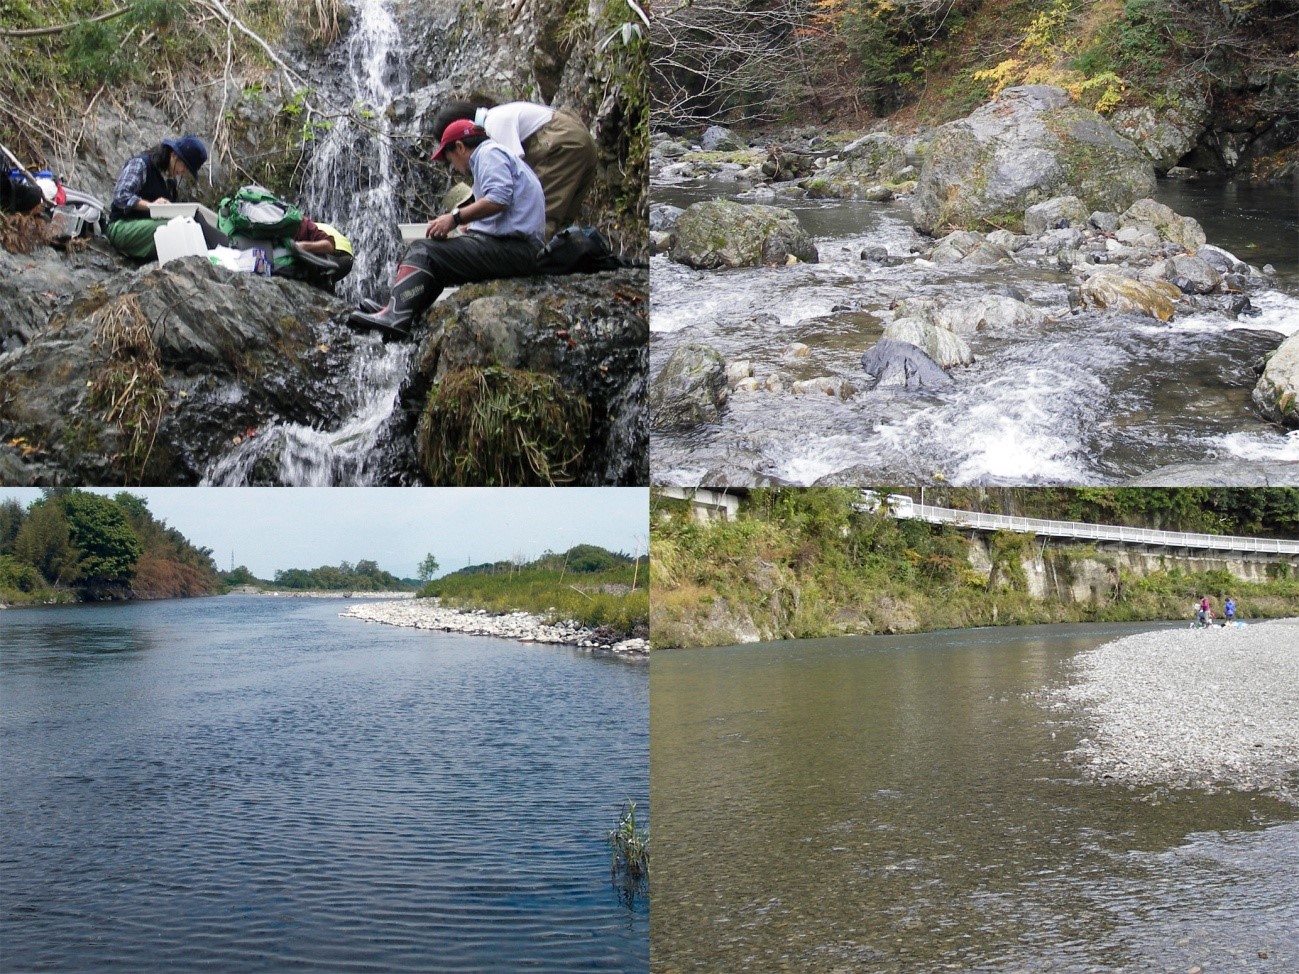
[105,135,230,260]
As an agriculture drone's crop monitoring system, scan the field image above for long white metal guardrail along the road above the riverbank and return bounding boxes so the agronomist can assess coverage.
[890,499,1299,555]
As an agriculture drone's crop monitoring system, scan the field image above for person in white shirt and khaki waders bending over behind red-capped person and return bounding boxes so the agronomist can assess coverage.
[433,97,596,239]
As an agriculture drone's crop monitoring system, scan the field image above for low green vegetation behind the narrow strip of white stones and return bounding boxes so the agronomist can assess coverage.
[420,544,650,638]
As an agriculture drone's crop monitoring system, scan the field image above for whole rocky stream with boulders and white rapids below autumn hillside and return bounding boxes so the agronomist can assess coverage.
[651,88,1299,486]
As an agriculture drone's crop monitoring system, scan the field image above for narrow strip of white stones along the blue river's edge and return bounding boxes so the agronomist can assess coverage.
[339,599,650,657]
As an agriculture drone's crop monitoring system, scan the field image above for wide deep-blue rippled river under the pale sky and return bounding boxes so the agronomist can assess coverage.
[0,596,650,971]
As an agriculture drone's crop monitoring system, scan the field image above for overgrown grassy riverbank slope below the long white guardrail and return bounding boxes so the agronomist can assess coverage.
[651,488,1299,648]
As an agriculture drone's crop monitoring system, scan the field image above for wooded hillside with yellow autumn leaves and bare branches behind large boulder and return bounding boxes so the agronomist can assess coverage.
[651,0,1299,171]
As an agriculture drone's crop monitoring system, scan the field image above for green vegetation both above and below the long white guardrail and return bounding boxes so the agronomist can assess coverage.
[651,488,1299,647]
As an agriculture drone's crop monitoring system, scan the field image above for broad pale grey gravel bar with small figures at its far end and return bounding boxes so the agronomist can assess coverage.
[1056,619,1299,801]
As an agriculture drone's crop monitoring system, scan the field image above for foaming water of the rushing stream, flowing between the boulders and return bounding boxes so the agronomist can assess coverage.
[651,179,1299,487]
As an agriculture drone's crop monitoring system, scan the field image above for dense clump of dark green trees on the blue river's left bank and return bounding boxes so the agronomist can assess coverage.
[0,488,222,604]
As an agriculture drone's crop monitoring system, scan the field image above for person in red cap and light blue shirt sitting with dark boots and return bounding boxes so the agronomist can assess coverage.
[347,119,546,338]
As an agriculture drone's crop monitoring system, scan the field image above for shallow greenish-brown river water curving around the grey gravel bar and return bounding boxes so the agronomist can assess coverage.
[651,625,1299,974]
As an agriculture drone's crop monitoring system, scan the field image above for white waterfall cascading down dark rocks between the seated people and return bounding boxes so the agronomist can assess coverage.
[203,0,412,487]
